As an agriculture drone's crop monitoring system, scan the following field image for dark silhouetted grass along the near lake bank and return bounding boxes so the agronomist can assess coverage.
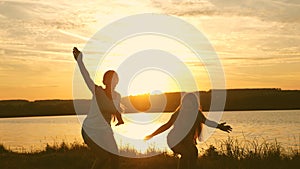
[0,138,300,169]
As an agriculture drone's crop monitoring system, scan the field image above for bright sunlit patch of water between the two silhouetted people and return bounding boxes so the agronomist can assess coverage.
[112,113,169,153]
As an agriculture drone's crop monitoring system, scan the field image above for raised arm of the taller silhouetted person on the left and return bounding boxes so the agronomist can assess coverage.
[73,47,95,93]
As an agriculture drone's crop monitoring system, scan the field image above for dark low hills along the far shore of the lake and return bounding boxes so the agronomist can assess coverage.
[0,88,300,118]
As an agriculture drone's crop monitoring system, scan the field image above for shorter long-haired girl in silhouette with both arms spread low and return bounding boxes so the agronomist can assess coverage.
[145,93,232,169]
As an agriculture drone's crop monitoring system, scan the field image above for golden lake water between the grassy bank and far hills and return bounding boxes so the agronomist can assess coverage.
[0,110,300,152]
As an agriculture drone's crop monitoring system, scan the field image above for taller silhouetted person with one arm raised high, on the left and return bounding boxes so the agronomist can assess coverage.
[73,47,124,169]
